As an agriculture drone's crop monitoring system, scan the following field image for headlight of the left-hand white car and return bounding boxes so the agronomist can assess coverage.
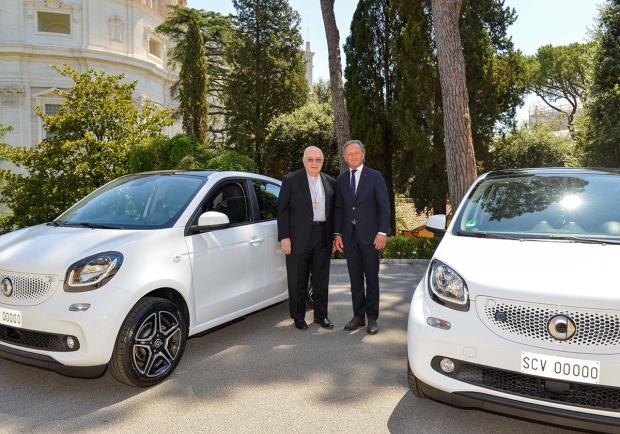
[64,252,123,292]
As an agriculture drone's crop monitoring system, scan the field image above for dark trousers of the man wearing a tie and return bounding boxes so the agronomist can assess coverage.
[344,226,379,321]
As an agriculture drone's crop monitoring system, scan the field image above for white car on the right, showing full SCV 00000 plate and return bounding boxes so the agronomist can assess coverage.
[407,169,620,432]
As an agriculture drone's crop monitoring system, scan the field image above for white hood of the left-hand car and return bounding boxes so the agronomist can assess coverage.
[0,224,150,280]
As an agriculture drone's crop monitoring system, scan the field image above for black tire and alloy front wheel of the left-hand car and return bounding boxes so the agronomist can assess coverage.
[109,297,187,387]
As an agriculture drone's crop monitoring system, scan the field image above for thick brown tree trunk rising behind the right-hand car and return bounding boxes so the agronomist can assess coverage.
[432,0,477,210]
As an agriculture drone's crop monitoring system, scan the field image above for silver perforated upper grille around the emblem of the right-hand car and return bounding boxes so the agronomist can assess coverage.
[476,296,620,354]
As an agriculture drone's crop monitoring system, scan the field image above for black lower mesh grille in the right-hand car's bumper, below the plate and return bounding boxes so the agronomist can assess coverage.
[431,357,620,411]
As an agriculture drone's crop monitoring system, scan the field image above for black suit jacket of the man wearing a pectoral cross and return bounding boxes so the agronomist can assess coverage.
[278,169,336,254]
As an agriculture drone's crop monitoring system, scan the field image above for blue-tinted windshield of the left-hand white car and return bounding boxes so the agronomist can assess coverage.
[53,174,206,229]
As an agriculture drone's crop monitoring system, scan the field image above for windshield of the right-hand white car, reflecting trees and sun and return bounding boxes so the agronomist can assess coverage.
[454,173,620,243]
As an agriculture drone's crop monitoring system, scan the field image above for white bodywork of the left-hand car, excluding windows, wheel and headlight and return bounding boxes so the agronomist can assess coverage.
[0,172,288,367]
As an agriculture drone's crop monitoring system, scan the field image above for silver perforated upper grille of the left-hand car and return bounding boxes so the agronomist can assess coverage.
[0,270,58,306]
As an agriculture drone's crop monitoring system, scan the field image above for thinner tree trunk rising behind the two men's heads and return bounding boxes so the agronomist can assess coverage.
[321,0,351,173]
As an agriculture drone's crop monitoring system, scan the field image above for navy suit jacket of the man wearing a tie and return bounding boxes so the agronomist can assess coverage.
[334,165,390,245]
